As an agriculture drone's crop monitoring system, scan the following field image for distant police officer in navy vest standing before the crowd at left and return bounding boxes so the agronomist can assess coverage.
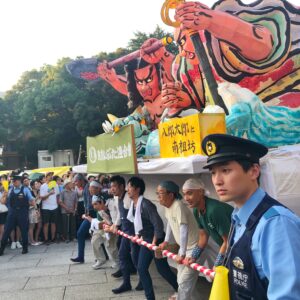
[0,175,34,256]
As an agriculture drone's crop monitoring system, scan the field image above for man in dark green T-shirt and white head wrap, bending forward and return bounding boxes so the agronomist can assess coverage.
[182,178,233,266]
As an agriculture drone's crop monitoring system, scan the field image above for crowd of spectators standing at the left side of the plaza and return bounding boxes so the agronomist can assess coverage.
[0,171,108,254]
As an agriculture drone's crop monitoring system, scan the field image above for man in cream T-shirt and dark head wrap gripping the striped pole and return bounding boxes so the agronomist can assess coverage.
[156,181,200,300]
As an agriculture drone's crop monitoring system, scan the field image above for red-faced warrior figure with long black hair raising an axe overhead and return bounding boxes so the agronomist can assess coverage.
[67,38,177,128]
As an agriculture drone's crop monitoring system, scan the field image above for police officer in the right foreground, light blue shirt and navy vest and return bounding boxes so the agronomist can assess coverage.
[202,134,300,300]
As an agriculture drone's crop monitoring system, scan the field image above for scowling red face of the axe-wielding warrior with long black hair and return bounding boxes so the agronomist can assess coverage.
[134,65,160,100]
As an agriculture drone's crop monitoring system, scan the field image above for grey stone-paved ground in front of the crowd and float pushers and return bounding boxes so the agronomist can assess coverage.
[0,241,210,300]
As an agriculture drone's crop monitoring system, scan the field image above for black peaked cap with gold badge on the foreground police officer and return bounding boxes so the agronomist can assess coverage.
[202,134,268,169]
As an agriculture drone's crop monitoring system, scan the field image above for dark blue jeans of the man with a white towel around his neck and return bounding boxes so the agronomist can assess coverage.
[134,239,178,300]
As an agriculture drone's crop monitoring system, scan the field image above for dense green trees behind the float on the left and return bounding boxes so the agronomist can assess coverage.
[0,27,173,167]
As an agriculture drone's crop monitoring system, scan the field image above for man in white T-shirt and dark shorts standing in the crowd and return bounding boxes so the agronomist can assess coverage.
[40,172,59,245]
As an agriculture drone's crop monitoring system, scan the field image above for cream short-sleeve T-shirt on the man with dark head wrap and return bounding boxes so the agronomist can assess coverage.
[165,200,199,250]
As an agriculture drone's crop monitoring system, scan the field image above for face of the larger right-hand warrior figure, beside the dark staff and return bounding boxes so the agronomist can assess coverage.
[174,29,199,65]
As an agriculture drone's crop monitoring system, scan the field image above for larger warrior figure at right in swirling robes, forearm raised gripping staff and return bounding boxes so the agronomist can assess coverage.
[162,0,300,107]
